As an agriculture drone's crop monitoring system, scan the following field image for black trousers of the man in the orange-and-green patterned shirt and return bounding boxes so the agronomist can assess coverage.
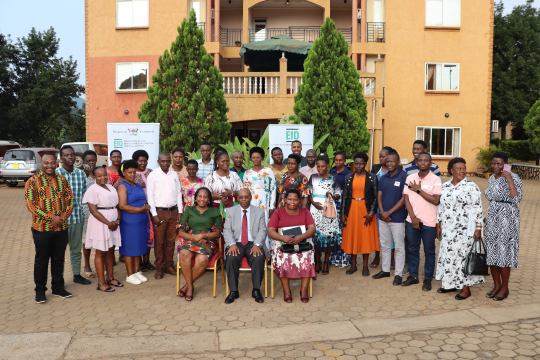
[32,229,68,292]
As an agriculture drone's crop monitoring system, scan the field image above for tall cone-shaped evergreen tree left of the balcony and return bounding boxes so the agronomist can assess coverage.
[138,10,231,151]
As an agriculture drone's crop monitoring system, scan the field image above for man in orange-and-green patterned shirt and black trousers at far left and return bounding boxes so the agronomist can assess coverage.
[25,153,73,304]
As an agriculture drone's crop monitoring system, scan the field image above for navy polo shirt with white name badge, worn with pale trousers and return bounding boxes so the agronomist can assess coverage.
[379,169,407,223]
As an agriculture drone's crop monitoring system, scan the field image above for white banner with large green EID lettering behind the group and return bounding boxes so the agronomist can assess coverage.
[268,124,315,163]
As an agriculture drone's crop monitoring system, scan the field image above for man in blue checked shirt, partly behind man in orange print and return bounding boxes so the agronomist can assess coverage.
[56,145,91,285]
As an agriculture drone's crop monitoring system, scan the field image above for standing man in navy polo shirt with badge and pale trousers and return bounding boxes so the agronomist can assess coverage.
[373,151,407,285]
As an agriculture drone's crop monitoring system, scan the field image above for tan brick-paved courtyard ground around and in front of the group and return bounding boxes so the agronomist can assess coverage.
[0,178,540,359]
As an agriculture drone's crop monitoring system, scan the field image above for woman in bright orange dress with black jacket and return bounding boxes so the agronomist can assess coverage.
[340,152,380,276]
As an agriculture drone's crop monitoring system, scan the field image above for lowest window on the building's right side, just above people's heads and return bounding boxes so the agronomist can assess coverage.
[416,126,461,157]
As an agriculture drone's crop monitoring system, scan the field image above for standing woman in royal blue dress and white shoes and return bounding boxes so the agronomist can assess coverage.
[118,160,150,285]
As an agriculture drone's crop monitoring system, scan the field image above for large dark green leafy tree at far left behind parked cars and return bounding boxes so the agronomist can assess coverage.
[0,27,86,146]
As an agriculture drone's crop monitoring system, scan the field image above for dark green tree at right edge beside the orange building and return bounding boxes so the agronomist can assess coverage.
[491,0,540,134]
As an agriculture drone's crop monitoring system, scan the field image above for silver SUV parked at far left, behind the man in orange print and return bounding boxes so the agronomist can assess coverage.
[0,148,58,187]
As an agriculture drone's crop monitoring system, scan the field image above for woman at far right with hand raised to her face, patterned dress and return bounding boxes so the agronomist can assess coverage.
[484,151,523,301]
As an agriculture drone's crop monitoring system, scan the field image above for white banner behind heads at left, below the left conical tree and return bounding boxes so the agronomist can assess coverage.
[107,123,159,169]
